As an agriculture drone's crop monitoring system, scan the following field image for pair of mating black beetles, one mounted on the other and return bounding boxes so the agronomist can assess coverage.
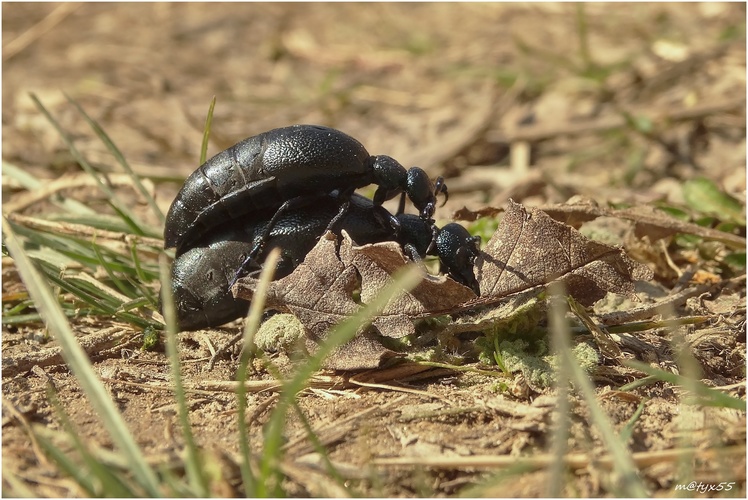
[164,125,478,329]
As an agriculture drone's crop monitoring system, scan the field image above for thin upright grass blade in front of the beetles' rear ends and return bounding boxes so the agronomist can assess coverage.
[159,254,210,497]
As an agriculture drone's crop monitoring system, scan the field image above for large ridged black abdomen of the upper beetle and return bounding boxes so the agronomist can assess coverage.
[164,125,373,248]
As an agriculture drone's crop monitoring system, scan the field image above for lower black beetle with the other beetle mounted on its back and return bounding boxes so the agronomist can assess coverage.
[172,195,479,330]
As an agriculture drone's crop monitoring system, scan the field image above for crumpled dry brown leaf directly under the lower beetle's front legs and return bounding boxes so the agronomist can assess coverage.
[234,232,475,370]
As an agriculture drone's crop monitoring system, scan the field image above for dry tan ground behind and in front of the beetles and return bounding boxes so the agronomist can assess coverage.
[2,3,746,497]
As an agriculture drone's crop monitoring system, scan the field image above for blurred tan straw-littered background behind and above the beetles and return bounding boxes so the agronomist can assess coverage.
[2,3,746,219]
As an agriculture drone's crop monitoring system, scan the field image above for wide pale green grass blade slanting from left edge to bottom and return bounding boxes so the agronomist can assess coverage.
[3,217,160,497]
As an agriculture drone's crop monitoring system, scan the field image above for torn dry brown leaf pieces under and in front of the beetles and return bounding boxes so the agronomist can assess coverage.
[234,202,652,369]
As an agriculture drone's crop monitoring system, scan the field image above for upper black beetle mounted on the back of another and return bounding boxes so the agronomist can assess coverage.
[164,125,447,250]
